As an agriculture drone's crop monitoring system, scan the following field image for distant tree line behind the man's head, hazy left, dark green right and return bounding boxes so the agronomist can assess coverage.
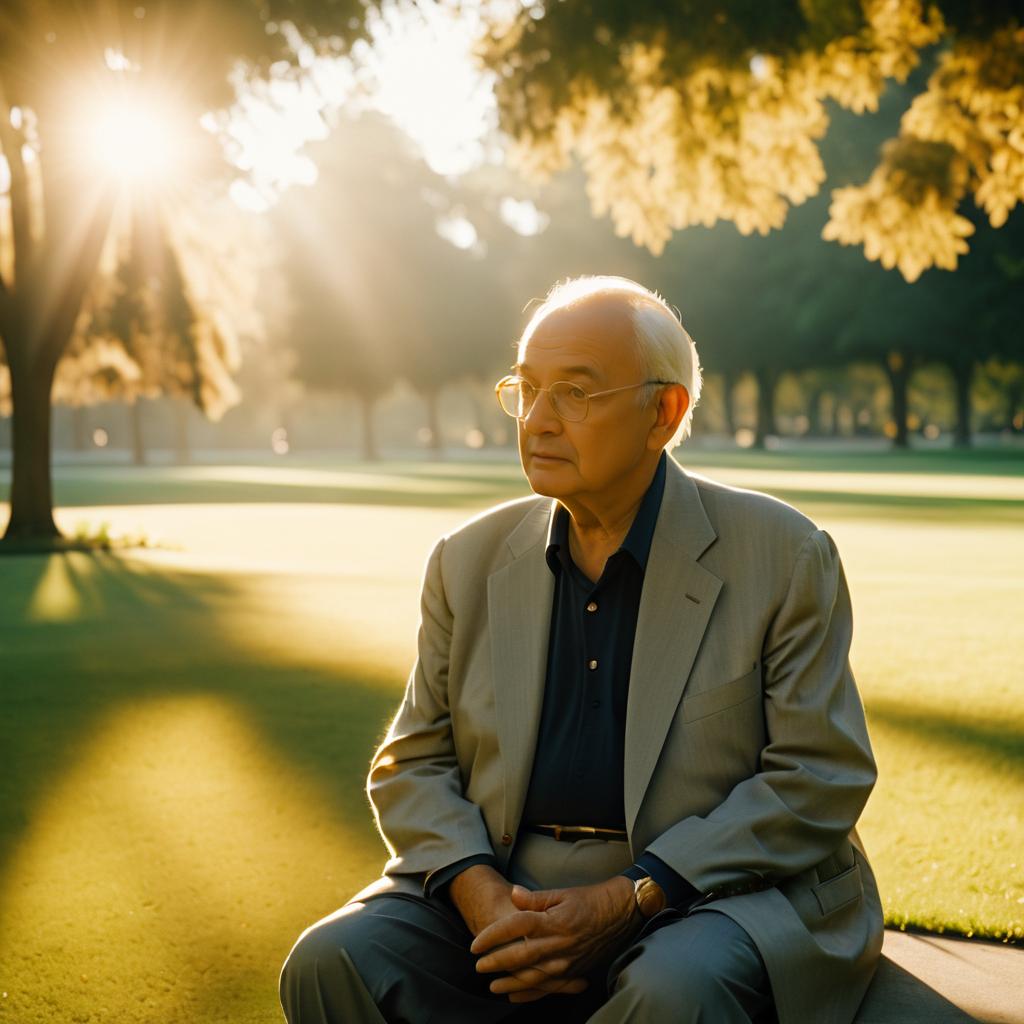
[273,90,1024,458]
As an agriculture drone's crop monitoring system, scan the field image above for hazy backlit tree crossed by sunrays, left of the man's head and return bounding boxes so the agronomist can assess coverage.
[272,113,520,458]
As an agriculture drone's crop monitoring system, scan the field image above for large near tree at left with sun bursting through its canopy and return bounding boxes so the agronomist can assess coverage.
[0,0,364,541]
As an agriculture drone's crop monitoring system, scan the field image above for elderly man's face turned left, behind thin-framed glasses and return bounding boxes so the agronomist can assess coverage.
[516,296,656,501]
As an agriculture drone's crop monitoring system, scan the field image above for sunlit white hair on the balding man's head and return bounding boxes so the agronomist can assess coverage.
[518,274,701,450]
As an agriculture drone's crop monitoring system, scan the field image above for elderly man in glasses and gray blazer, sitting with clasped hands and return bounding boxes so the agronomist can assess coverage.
[281,278,883,1024]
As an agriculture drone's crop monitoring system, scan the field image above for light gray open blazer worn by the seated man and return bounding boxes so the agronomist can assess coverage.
[352,458,883,1024]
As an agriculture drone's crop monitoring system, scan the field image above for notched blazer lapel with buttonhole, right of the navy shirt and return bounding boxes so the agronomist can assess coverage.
[624,456,722,836]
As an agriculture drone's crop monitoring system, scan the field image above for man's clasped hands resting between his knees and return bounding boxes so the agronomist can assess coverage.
[449,865,643,1002]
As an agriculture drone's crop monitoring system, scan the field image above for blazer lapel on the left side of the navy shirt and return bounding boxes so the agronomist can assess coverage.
[487,500,555,834]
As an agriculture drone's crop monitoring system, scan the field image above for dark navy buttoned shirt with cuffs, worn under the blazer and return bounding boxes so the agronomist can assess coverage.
[427,452,700,905]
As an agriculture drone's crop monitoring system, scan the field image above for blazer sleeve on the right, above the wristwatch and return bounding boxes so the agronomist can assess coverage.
[647,529,878,893]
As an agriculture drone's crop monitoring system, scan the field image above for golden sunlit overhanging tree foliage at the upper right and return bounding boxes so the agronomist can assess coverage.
[471,0,1024,281]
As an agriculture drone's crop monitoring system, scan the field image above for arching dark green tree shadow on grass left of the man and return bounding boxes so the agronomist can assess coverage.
[0,554,402,881]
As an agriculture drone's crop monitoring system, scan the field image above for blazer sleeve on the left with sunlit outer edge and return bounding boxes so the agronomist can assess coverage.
[367,538,494,892]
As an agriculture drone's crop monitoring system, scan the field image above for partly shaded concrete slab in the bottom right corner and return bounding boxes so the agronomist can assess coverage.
[856,929,1024,1024]
